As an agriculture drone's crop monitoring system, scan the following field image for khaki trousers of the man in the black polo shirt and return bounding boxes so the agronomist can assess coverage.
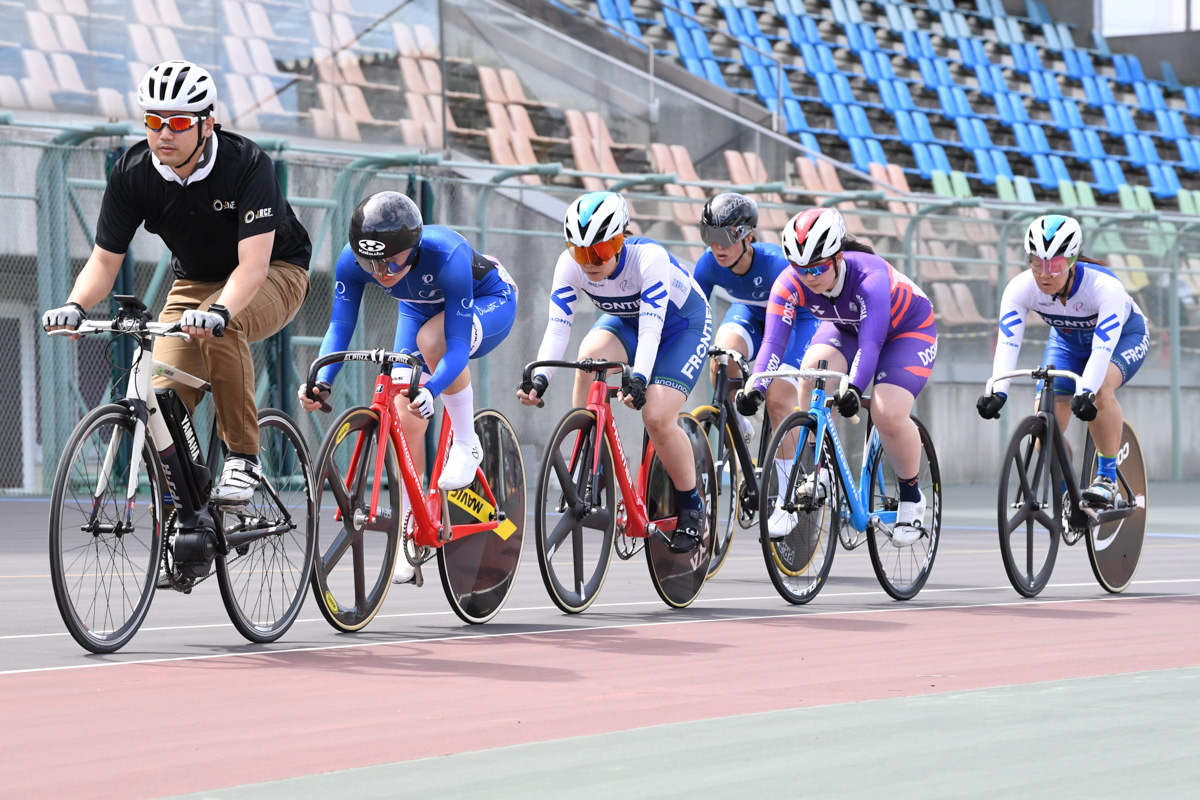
[154,261,308,455]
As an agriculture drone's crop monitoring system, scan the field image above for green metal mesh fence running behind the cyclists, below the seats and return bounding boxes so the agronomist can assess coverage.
[0,126,1200,492]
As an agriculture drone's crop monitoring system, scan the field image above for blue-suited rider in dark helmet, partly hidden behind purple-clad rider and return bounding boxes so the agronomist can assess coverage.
[696,192,817,441]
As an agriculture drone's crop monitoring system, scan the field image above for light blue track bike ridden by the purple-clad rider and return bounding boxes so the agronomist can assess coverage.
[749,361,942,603]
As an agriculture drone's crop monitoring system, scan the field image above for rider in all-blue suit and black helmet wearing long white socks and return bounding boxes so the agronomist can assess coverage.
[299,192,517,583]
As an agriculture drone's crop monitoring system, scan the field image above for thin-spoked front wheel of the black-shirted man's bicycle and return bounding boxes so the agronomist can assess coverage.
[50,404,163,652]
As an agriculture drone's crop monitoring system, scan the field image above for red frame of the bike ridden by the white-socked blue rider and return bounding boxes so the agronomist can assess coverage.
[335,365,500,547]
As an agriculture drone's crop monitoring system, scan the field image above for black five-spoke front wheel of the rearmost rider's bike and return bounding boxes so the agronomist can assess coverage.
[997,416,1062,597]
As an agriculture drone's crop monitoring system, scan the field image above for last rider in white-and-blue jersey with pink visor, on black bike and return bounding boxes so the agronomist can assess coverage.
[976,213,1150,507]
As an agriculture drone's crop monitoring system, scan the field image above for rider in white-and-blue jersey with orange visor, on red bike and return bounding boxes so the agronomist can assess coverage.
[517,192,713,553]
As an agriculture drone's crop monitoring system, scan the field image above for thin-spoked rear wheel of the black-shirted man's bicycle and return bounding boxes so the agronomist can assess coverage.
[217,408,317,642]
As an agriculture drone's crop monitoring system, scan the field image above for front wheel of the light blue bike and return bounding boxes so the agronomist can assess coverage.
[758,411,841,604]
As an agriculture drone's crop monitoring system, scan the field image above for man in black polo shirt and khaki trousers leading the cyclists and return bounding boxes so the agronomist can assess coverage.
[42,61,312,505]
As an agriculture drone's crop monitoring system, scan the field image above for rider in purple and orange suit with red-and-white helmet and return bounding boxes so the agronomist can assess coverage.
[744,209,937,547]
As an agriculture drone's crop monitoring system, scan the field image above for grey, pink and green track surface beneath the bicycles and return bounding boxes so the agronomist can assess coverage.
[0,485,1200,798]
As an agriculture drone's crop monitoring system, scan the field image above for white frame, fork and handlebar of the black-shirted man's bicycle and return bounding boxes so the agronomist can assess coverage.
[49,319,210,513]
